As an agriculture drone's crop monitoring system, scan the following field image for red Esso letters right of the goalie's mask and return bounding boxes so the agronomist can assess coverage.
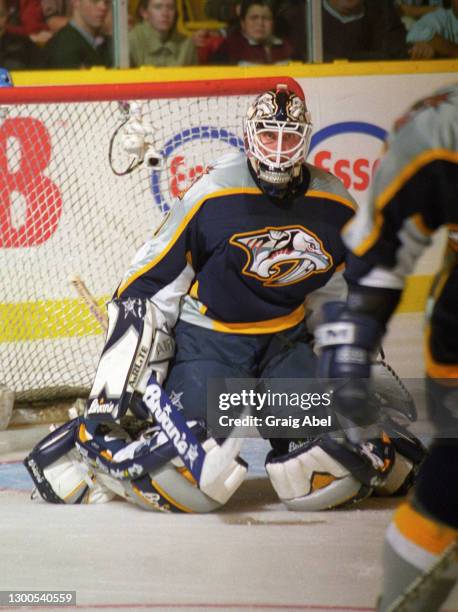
[312,149,380,191]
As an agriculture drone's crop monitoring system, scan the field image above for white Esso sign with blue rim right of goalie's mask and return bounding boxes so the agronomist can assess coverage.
[309,121,387,195]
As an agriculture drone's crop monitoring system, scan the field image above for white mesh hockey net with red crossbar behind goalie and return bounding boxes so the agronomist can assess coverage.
[0,77,297,401]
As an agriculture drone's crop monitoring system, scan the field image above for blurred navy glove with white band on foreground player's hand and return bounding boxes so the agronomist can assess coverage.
[315,302,384,426]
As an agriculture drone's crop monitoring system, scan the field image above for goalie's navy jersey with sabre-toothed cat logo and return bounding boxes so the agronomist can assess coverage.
[118,153,356,334]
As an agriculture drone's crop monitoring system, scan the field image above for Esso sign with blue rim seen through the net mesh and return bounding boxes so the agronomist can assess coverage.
[151,125,244,212]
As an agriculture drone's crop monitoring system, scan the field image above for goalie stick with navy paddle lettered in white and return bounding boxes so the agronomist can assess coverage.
[71,276,242,503]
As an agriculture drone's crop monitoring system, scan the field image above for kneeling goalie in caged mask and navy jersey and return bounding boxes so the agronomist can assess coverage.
[27,84,421,512]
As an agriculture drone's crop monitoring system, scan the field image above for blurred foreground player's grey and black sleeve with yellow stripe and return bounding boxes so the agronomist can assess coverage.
[344,86,458,289]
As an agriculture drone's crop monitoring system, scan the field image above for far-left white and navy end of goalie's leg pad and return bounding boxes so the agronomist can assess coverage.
[24,419,114,504]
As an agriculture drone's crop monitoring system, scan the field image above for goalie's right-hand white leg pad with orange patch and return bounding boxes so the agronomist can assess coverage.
[266,438,372,512]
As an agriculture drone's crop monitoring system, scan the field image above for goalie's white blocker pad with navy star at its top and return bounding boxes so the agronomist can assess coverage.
[85,298,175,422]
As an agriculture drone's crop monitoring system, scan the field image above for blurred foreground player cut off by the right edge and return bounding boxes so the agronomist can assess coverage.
[318,84,458,612]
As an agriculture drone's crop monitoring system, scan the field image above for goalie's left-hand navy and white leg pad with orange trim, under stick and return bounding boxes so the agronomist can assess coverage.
[76,420,247,513]
